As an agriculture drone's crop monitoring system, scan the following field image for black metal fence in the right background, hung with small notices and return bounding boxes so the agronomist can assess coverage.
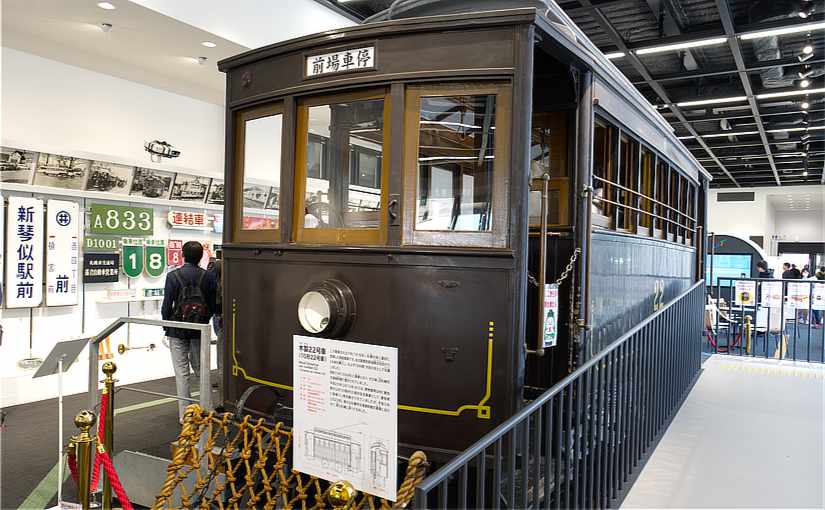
[704,277,825,363]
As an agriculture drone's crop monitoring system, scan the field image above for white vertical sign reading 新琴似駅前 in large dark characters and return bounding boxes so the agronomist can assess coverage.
[4,197,44,308]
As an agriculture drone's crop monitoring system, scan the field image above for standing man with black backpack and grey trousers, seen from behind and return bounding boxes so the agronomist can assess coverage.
[161,241,218,423]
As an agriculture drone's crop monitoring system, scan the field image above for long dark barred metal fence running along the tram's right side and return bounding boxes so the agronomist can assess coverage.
[414,282,705,508]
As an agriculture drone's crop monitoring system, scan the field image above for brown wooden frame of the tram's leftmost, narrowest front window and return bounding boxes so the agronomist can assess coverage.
[230,101,286,243]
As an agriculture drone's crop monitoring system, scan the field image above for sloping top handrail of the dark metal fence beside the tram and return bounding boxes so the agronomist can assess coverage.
[418,280,704,494]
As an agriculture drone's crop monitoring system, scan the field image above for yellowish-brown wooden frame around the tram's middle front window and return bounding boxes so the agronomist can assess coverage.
[292,88,392,246]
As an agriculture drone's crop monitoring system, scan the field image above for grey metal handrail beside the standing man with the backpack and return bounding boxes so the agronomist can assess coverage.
[81,317,212,409]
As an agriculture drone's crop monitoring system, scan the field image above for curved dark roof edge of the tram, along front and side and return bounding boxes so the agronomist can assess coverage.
[218,5,712,180]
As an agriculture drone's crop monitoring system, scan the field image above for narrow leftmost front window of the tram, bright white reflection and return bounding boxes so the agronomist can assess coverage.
[233,105,283,242]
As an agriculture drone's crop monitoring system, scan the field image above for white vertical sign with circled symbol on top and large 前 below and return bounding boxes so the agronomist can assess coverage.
[46,200,82,306]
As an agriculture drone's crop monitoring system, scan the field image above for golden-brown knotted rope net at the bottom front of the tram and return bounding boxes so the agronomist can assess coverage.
[152,404,428,510]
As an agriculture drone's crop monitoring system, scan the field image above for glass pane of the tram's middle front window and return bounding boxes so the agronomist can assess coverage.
[303,99,384,229]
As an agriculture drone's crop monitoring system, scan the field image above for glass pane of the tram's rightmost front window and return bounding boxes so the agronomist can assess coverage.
[415,94,496,232]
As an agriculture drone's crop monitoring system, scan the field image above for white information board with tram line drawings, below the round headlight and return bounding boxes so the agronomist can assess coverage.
[292,335,398,501]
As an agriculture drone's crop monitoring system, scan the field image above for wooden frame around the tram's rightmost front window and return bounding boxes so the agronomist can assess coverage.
[402,82,512,248]
